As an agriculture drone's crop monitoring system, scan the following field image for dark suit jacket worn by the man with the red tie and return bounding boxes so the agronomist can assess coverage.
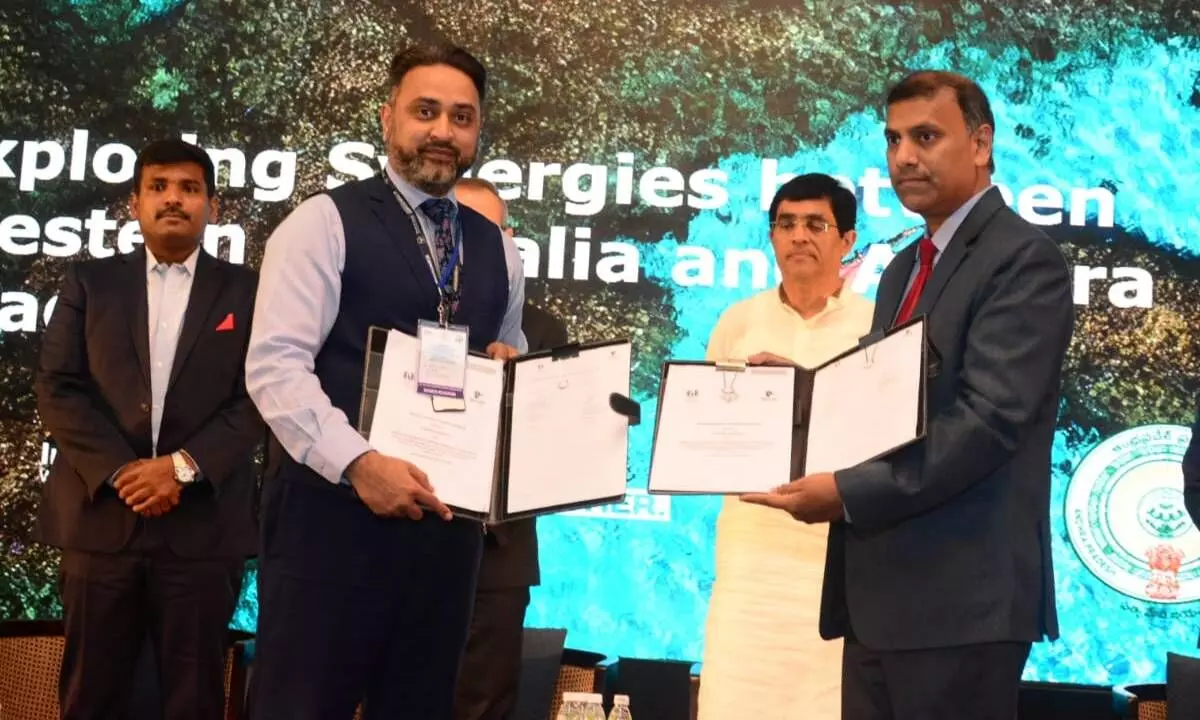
[821,188,1074,652]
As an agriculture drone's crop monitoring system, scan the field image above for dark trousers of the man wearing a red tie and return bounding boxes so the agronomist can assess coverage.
[841,640,1032,720]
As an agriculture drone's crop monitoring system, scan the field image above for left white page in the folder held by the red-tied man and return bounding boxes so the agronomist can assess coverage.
[649,365,796,494]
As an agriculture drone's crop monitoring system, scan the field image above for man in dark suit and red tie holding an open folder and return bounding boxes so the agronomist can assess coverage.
[748,72,1074,720]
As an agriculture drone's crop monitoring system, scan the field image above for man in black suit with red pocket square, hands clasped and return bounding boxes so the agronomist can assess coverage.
[36,140,264,720]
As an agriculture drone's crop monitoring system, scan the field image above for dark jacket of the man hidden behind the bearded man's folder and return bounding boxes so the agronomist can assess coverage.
[478,304,566,590]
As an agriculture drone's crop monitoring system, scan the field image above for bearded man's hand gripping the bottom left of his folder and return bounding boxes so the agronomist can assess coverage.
[346,450,454,520]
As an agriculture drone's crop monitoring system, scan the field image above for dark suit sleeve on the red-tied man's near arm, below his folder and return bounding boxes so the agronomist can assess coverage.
[835,239,1075,532]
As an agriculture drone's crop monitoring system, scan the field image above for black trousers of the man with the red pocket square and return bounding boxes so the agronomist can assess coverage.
[59,524,245,720]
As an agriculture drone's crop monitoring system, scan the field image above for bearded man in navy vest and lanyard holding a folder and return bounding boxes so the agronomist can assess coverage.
[246,46,526,720]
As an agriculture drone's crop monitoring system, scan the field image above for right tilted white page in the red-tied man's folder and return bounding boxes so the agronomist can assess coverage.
[804,320,925,475]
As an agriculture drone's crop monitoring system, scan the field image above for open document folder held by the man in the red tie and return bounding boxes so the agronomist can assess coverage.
[649,316,928,494]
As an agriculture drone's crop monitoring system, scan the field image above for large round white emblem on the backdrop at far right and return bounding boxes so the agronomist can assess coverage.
[1064,425,1200,604]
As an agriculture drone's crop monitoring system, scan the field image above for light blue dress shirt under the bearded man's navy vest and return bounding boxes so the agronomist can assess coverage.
[246,164,529,482]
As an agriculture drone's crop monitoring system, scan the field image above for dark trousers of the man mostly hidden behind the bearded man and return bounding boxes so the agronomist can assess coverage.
[454,587,529,720]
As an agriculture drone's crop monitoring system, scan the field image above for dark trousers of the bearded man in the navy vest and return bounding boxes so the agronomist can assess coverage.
[250,479,482,720]
